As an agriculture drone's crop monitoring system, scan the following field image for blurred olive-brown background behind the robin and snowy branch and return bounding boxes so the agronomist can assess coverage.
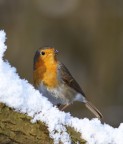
[0,0,123,126]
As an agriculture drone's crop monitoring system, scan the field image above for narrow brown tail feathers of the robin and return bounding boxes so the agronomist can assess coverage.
[85,101,103,119]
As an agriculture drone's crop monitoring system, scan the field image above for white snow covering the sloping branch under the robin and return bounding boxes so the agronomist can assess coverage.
[0,30,123,144]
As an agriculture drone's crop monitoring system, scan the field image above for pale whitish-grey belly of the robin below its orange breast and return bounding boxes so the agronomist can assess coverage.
[38,84,85,105]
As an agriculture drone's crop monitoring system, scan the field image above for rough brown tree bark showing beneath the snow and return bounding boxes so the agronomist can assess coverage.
[0,103,86,144]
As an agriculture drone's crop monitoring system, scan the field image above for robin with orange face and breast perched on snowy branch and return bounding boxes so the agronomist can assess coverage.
[33,47,103,119]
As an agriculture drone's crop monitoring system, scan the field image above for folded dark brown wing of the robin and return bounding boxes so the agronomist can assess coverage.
[58,62,85,97]
